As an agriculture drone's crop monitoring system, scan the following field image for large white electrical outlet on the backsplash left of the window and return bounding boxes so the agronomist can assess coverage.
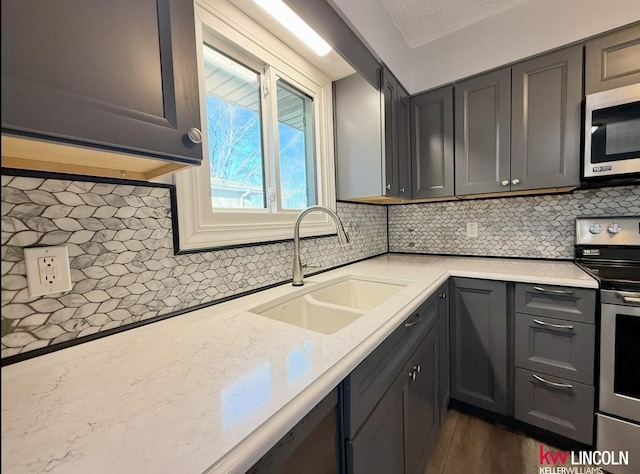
[24,245,71,297]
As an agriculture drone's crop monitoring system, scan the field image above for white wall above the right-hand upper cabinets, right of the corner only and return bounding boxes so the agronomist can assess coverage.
[405,0,640,93]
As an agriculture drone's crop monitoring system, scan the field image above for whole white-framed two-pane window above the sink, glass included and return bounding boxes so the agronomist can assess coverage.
[176,0,335,250]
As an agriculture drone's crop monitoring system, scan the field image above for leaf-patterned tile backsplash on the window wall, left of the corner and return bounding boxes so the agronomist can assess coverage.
[1,176,387,358]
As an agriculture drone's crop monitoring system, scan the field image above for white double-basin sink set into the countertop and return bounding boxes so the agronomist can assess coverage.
[250,276,408,334]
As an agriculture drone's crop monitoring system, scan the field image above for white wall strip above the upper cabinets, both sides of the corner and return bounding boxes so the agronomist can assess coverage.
[331,0,640,94]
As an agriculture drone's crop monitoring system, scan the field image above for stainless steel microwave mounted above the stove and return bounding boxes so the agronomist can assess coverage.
[582,84,640,180]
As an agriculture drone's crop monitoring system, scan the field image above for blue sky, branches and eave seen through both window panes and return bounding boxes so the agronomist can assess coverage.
[204,45,315,209]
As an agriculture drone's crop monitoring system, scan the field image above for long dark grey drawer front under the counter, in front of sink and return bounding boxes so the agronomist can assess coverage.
[343,295,439,438]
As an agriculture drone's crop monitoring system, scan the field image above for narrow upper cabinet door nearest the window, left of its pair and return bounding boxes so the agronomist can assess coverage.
[382,69,399,196]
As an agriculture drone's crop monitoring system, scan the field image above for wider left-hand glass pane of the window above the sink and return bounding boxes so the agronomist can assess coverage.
[204,44,266,209]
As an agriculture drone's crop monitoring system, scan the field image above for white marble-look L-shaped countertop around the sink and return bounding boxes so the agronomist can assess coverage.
[2,254,597,474]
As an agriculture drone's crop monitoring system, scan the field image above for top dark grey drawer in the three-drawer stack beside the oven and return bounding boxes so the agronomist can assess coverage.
[515,283,596,324]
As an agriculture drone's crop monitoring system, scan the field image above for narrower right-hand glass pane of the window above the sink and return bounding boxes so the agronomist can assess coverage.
[277,79,316,209]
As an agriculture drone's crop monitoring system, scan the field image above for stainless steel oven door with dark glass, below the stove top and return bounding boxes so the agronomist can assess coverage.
[600,291,640,423]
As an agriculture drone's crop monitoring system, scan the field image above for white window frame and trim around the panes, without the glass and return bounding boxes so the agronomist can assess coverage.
[176,0,335,250]
